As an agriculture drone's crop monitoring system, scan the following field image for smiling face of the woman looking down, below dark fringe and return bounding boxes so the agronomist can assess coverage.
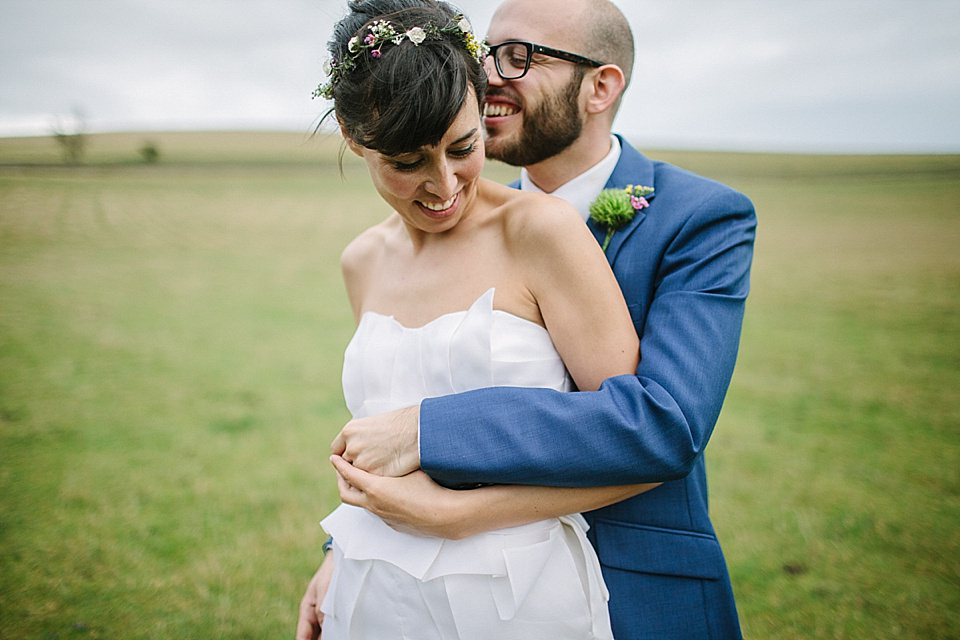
[347,88,484,233]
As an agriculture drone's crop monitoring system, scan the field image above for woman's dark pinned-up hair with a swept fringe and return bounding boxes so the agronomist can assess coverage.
[327,0,487,155]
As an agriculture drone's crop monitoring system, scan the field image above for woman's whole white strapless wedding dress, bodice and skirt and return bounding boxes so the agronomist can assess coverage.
[321,289,613,640]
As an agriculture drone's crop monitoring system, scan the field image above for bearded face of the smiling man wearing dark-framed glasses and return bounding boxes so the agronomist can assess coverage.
[483,0,584,166]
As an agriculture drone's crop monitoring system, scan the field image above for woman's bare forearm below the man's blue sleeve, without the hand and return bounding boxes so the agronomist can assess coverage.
[443,484,659,538]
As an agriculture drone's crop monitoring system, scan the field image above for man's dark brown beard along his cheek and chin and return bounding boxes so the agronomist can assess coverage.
[486,67,584,167]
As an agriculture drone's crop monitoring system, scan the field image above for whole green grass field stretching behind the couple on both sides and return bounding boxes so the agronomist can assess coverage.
[0,134,960,639]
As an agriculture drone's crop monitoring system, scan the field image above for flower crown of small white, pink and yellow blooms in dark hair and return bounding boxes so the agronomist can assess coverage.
[313,15,489,100]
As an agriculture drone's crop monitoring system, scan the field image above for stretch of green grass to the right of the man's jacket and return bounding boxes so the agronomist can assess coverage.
[708,158,960,638]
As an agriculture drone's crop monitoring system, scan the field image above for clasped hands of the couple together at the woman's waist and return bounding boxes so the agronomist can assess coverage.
[330,406,463,538]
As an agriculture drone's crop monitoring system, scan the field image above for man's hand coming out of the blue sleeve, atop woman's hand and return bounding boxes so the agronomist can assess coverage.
[330,406,420,477]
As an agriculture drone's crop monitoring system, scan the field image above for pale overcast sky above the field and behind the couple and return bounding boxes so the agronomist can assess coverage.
[0,0,960,153]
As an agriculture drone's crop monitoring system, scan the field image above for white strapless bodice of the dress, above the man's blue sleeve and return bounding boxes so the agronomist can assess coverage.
[343,289,572,418]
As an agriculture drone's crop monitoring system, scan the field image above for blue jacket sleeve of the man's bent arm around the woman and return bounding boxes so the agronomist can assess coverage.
[420,190,756,486]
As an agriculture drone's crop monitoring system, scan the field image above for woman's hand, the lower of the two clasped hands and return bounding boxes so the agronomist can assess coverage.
[330,455,466,539]
